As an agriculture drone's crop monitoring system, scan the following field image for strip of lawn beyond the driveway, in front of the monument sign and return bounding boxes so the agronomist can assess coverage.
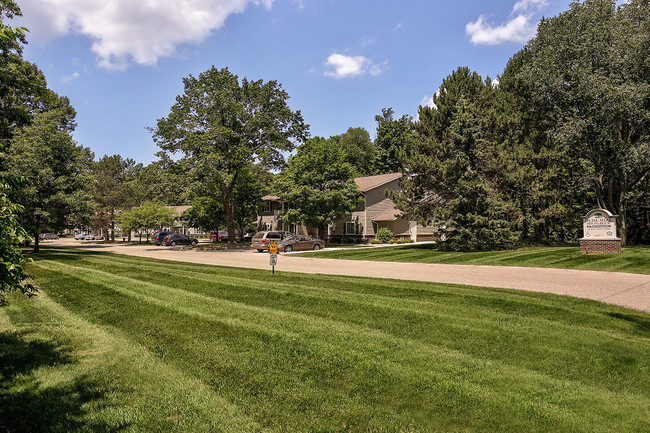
[300,244,650,274]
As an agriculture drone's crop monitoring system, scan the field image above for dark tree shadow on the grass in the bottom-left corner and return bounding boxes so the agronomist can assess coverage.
[0,333,123,433]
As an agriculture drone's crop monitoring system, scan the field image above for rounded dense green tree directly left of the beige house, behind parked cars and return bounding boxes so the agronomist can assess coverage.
[278,137,362,238]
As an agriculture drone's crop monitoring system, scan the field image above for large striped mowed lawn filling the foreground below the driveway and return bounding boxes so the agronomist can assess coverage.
[0,249,650,433]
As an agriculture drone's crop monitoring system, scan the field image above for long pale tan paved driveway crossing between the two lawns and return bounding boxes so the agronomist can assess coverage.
[46,239,650,313]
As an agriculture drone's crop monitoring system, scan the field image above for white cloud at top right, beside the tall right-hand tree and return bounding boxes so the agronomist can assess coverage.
[465,0,548,45]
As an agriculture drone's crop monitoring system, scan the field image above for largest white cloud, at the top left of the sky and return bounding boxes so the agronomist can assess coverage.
[15,0,273,69]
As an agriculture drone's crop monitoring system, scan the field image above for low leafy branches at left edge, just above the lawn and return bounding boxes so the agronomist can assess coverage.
[0,178,37,305]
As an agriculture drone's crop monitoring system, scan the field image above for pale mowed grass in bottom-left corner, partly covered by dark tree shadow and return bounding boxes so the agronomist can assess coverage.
[0,286,260,433]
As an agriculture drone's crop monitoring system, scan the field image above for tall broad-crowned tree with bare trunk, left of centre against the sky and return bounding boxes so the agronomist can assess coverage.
[152,66,308,242]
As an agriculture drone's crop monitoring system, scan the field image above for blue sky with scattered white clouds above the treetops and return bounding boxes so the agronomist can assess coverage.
[11,0,570,163]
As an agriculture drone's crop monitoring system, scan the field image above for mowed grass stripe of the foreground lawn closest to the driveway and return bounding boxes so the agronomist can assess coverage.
[71,250,645,338]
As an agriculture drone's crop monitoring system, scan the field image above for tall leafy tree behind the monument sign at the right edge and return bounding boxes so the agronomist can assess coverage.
[501,0,650,242]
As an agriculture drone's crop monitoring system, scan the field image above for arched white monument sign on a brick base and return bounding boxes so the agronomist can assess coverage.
[580,209,621,254]
